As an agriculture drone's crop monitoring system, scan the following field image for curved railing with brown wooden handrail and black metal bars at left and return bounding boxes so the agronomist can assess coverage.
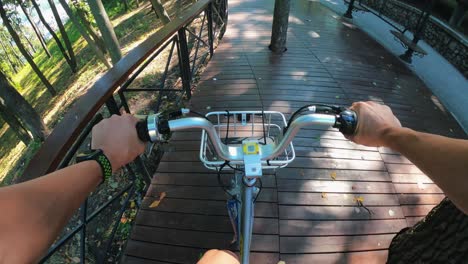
[20,0,227,263]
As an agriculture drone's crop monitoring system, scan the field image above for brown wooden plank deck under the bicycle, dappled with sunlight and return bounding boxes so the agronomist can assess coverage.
[124,0,466,264]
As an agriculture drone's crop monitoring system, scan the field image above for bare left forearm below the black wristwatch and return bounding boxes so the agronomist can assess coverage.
[0,161,102,263]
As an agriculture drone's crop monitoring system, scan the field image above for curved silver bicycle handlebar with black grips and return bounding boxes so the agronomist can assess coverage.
[136,106,357,161]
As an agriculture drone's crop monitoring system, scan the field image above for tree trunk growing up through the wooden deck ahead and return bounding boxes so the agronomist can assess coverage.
[269,0,290,53]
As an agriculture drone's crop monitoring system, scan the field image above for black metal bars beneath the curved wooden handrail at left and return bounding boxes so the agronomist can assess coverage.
[39,0,227,263]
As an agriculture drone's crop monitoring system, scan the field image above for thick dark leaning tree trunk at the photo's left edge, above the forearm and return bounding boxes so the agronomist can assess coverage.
[0,72,48,141]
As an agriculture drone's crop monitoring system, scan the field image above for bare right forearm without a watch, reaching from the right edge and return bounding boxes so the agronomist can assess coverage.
[385,128,468,213]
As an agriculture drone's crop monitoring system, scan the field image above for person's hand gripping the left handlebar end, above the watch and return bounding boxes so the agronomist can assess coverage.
[91,114,145,172]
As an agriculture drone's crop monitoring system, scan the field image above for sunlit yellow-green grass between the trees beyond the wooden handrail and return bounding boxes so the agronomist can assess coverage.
[0,0,187,185]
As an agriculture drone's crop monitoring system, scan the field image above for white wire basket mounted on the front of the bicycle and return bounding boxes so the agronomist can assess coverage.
[200,111,295,170]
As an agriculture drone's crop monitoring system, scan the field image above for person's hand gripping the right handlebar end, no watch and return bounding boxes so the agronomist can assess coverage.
[347,102,401,147]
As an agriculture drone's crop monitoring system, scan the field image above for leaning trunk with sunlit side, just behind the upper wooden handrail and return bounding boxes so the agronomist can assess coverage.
[88,0,122,64]
